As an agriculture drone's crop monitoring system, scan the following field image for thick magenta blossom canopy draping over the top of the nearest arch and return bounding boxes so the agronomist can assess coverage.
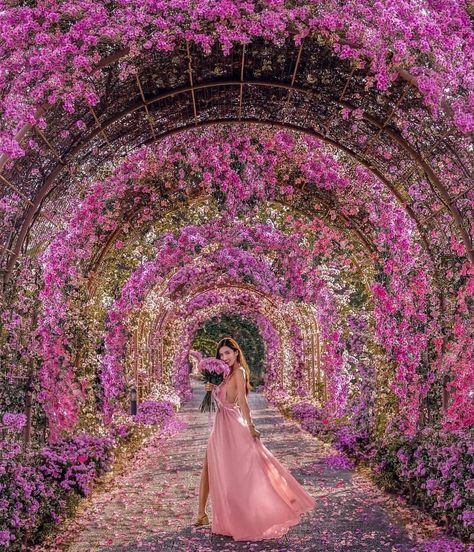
[0,0,473,164]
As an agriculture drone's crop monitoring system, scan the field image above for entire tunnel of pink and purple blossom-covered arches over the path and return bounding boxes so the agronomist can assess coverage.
[0,1,474,535]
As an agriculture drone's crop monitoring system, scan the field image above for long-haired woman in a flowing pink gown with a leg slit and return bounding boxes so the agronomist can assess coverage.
[194,337,315,541]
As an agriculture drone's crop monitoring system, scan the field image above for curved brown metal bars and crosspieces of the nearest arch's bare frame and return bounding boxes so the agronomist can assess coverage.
[0,42,474,281]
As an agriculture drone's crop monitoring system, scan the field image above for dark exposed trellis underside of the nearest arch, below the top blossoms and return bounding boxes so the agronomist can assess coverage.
[0,39,474,280]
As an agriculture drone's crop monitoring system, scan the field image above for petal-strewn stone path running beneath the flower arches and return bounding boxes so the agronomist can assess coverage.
[35,382,456,552]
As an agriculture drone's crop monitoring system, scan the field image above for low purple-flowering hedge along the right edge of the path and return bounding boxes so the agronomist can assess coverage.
[275,396,474,540]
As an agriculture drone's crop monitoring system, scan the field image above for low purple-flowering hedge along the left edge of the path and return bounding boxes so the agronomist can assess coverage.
[0,400,184,550]
